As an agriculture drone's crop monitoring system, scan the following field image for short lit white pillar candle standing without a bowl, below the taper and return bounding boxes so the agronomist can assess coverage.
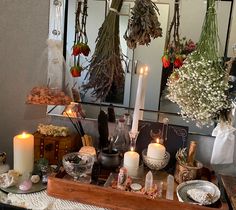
[124,151,139,175]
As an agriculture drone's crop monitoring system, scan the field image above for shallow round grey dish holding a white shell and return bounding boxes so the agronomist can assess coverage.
[176,180,220,205]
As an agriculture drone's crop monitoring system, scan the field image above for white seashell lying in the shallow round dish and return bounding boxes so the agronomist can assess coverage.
[187,189,213,205]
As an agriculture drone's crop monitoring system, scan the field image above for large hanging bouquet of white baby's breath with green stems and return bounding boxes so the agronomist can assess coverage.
[167,0,229,125]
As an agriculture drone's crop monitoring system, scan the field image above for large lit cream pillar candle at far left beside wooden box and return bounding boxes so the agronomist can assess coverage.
[13,133,34,174]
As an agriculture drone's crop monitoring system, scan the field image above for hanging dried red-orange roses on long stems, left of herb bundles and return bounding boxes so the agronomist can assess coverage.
[70,0,90,77]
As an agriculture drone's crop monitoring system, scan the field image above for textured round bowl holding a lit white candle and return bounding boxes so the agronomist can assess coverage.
[142,149,170,170]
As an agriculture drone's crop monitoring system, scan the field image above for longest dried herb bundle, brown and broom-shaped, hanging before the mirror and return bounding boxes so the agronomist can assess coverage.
[83,0,124,100]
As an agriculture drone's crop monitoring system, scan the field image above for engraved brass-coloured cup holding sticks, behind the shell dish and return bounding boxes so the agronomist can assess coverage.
[174,161,203,183]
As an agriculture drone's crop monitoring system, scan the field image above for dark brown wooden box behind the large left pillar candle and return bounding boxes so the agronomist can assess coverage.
[34,132,81,164]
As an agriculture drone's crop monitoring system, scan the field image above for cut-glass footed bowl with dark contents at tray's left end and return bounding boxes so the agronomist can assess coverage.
[62,152,94,181]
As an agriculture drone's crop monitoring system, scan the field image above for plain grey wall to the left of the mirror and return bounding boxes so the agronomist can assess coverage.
[0,0,49,167]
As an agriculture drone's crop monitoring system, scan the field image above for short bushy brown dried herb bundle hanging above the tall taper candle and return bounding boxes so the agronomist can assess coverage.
[124,0,162,49]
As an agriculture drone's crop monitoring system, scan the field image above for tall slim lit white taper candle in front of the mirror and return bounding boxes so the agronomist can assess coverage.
[131,68,144,133]
